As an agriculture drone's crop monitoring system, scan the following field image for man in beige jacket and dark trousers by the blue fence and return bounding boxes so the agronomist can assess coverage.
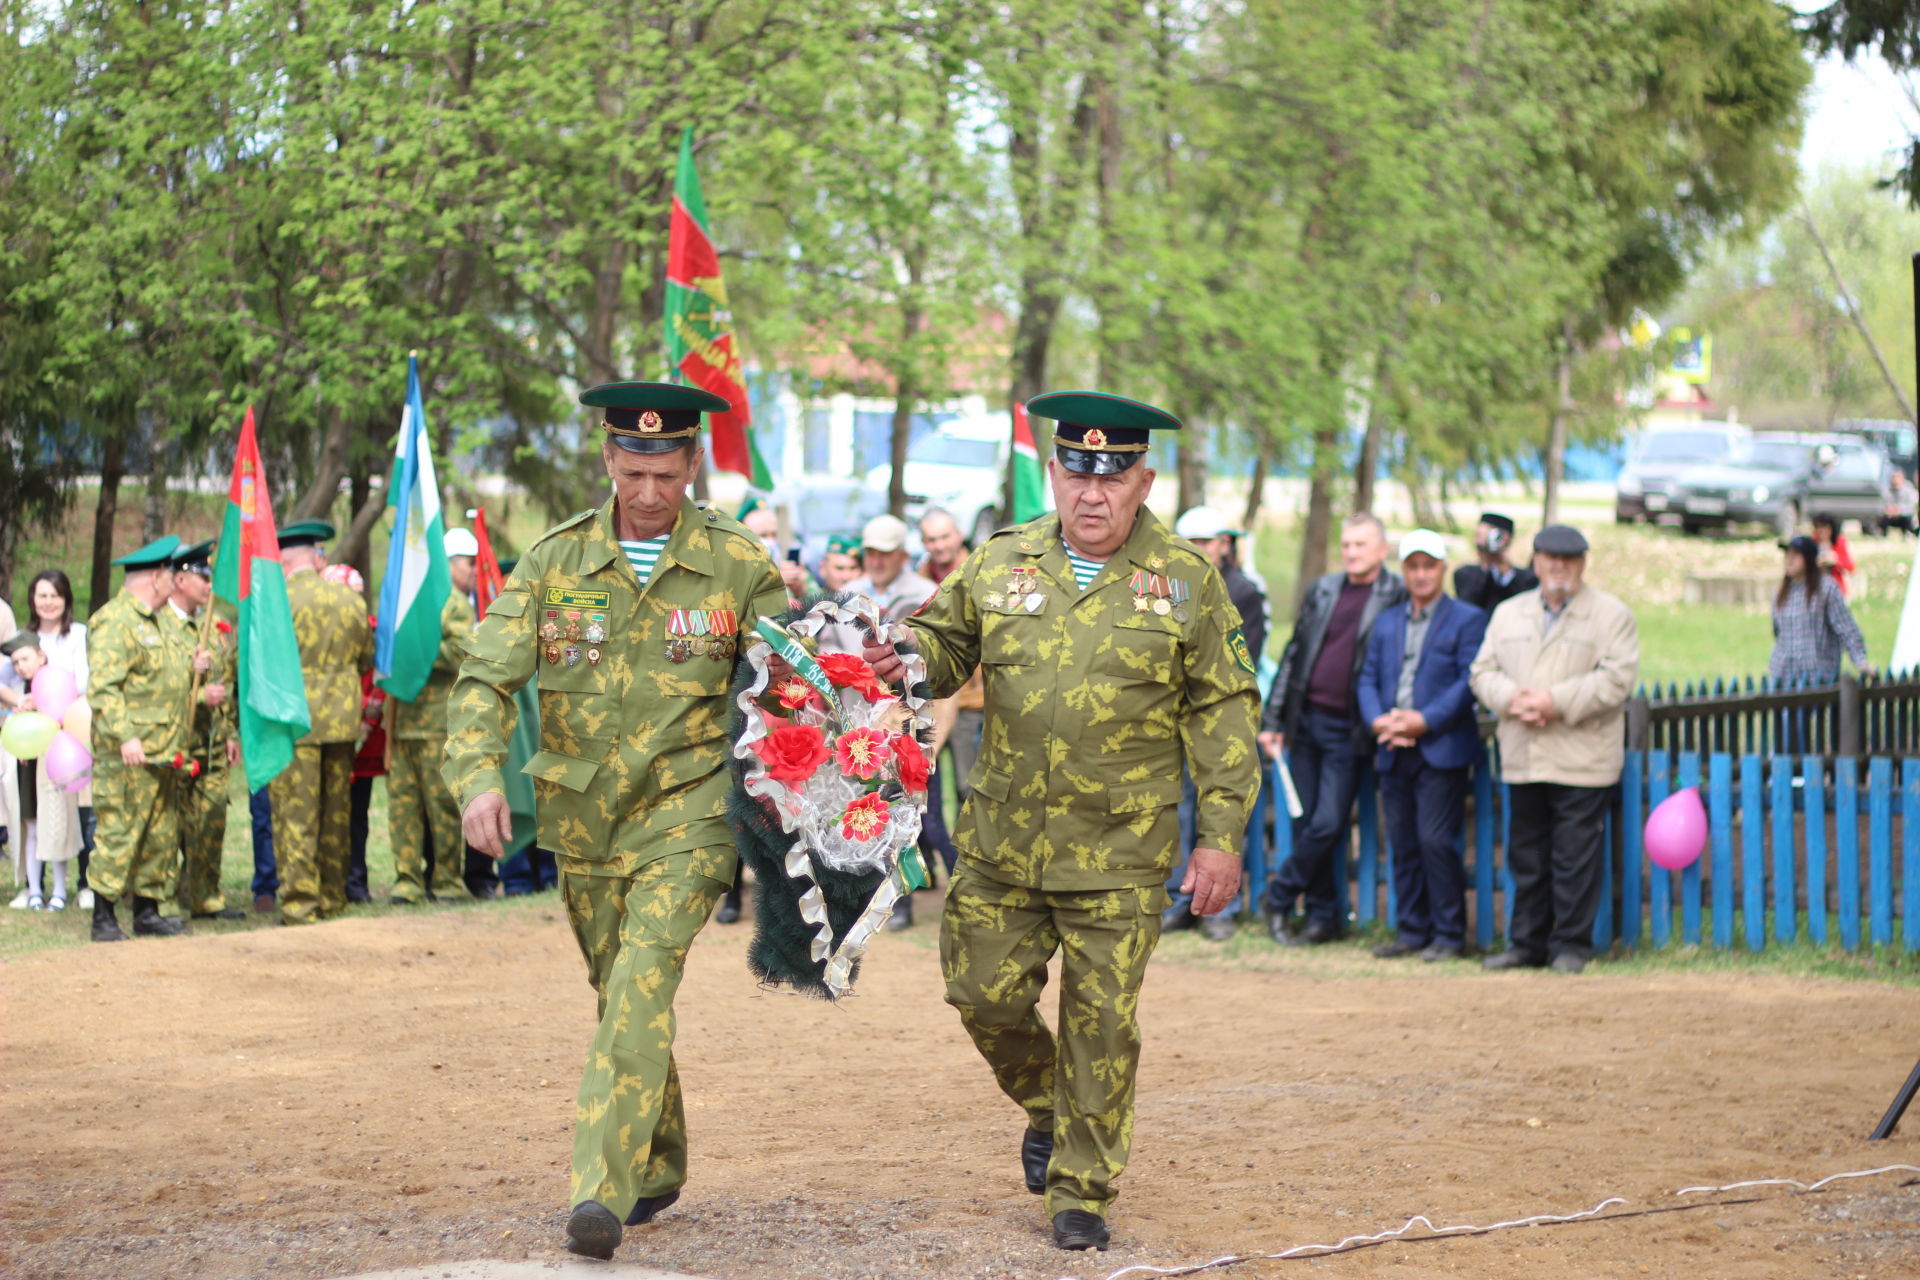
[1473,524,1640,973]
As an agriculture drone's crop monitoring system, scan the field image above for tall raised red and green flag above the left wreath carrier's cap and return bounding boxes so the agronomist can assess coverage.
[666,125,774,489]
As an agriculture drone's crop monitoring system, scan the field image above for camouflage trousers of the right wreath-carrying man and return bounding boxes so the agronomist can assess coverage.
[941,860,1167,1215]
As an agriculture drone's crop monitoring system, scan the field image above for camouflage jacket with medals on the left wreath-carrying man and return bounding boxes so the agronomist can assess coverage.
[444,501,787,879]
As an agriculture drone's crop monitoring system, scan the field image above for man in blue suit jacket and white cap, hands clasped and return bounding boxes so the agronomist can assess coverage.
[1359,530,1486,960]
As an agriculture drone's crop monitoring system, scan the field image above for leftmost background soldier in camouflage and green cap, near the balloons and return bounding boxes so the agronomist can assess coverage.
[86,537,190,942]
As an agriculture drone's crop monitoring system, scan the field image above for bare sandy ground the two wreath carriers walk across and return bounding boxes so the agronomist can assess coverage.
[0,898,1920,1280]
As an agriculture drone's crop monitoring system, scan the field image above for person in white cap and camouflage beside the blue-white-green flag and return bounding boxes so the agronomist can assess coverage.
[386,530,478,904]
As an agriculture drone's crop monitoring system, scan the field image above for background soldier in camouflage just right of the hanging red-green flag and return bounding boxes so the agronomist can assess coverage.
[267,520,372,925]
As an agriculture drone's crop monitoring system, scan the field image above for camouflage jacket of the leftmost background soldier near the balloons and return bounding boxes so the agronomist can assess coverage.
[86,591,192,764]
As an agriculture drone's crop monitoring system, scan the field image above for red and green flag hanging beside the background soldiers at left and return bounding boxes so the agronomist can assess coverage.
[213,405,313,791]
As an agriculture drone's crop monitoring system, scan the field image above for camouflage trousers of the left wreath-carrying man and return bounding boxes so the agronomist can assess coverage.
[561,848,733,1219]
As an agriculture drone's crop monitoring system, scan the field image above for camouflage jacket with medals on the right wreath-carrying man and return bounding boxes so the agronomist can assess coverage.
[908,509,1260,892]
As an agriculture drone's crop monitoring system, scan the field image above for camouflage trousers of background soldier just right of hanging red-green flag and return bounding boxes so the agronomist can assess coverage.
[267,743,353,925]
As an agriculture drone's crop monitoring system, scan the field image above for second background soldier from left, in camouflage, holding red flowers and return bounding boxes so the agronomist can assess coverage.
[159,539,246,919]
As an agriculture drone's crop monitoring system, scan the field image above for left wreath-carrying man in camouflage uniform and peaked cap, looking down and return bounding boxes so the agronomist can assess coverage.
[445,382,787,1259]
